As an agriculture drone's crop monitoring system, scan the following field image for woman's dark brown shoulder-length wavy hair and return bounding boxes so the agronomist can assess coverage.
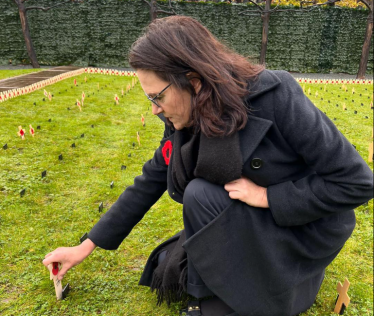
[129,16,264,137]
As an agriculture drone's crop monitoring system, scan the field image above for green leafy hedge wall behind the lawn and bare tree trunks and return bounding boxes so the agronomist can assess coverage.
[0,0,373,74]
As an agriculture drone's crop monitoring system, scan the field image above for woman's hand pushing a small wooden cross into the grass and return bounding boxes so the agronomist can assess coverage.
[43,239,96,280]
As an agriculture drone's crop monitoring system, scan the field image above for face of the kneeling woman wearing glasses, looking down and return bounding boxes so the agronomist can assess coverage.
[137,70,191,130]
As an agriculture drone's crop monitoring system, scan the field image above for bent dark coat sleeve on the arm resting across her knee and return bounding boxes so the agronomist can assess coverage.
[267,72,373,226]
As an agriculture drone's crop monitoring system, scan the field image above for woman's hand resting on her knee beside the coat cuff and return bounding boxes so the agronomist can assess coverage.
[225,176,269,208]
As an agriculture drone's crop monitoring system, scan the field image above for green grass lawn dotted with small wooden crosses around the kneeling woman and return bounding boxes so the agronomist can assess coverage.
[0,72,373,316]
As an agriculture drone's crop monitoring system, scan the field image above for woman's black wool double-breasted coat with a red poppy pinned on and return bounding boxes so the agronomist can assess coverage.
[88,70,373,316]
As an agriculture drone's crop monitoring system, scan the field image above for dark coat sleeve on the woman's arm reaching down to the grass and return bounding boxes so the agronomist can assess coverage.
[88,123,170,250]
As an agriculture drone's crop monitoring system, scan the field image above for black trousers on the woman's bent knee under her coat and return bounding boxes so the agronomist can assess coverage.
[183,179,233,298]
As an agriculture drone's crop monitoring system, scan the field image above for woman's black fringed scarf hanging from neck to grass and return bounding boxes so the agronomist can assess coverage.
[150,129,243,305]
